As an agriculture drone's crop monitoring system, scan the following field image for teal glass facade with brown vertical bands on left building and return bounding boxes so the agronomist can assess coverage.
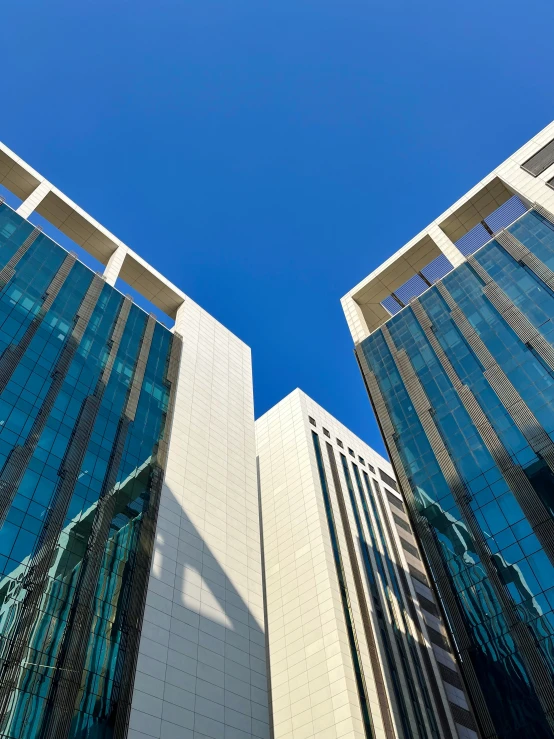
[0,205,180,739]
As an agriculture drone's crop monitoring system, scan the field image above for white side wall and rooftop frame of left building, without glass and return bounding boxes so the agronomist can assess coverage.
[0,144,269,739]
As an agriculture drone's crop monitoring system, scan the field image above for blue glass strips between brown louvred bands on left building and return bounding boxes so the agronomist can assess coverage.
[0,206,171,739]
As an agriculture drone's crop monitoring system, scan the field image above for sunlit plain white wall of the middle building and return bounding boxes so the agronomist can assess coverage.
[256,390,391,739]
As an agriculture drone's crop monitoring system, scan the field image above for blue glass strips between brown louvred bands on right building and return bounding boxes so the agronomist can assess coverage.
[362,207,554,736]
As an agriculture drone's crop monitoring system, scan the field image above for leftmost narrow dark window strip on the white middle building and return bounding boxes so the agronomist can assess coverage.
[312,431,374,738]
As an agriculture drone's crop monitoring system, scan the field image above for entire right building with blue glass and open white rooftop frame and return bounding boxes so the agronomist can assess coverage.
[342,118,554,739]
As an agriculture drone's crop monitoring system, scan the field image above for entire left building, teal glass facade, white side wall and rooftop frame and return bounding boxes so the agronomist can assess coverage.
[0,145,269,739]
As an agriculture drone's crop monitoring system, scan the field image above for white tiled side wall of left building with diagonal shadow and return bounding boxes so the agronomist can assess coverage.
[129,299,269,739]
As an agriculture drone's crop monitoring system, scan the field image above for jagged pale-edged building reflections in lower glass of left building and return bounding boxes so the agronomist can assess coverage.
[0,459,151,736]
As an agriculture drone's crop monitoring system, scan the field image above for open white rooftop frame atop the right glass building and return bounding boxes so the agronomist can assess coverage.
[341,122,554,344]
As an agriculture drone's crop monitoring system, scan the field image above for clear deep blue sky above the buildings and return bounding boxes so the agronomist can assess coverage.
[0,0,554,450]
